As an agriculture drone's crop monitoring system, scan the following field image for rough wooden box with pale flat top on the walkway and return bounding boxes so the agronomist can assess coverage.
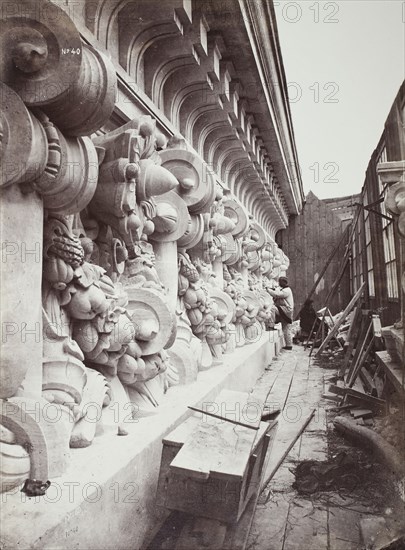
[157,392,276,523]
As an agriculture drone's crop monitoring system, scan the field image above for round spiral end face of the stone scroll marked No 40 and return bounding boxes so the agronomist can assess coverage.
[0,0,82,107]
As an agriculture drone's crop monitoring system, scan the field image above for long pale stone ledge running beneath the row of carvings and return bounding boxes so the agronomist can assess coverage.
[1,331,280,550]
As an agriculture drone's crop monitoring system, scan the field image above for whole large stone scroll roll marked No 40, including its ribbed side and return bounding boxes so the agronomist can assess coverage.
[0,0,117,136]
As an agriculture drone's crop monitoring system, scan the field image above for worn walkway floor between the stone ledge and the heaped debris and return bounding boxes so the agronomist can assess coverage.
[247,346,402,550]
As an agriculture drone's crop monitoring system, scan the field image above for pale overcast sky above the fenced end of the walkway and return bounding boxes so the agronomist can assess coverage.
[274,0,405,202]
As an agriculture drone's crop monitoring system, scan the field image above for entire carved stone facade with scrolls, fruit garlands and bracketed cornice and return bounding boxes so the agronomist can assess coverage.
[0,0,303,544]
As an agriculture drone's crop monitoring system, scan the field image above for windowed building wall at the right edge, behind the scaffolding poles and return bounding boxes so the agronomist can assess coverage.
[351,84,405,325]
